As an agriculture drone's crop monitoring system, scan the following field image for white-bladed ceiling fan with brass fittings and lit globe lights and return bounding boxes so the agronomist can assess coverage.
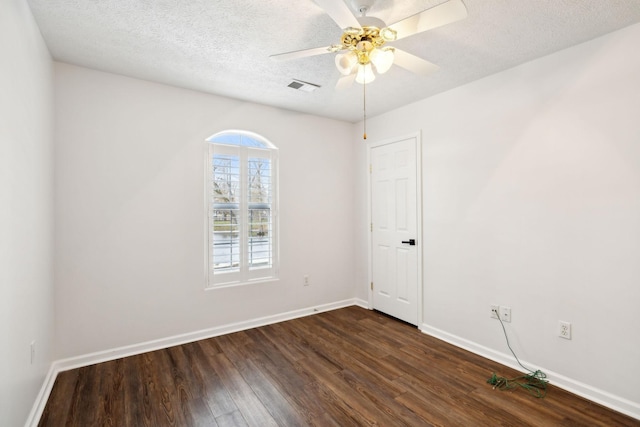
[271,0,467,88]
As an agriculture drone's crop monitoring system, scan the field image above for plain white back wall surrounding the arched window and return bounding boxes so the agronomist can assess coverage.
[55,64,355,358]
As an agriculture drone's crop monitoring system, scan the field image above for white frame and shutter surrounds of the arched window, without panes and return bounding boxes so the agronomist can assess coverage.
[205,130,279,289]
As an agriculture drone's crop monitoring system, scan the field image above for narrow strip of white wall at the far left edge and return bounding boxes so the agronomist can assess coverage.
[0,0,53,426]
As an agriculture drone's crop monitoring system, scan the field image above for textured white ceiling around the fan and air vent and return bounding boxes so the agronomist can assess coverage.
[28,0,640,122]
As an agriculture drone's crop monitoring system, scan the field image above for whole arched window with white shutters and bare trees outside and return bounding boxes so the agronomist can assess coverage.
[206,131,278,288]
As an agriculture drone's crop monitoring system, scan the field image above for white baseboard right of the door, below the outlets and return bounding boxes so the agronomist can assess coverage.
[420,323,640,420]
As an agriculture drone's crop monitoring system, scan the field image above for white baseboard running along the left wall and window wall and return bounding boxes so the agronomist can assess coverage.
[25,298,369,427]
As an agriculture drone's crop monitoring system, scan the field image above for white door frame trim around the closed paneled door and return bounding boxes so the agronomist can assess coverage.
[366,131,424,330]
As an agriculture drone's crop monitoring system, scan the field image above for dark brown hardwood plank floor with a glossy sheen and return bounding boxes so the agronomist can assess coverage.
[39,307,640,427]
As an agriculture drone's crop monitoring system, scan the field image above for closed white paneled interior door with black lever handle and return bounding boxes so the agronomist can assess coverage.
[370,137,421,325]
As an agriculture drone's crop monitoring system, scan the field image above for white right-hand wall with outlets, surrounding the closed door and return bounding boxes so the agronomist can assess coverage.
[354,25,640,417]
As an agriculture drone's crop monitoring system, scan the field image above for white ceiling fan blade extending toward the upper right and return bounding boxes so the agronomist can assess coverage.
[389,0,467,40]
